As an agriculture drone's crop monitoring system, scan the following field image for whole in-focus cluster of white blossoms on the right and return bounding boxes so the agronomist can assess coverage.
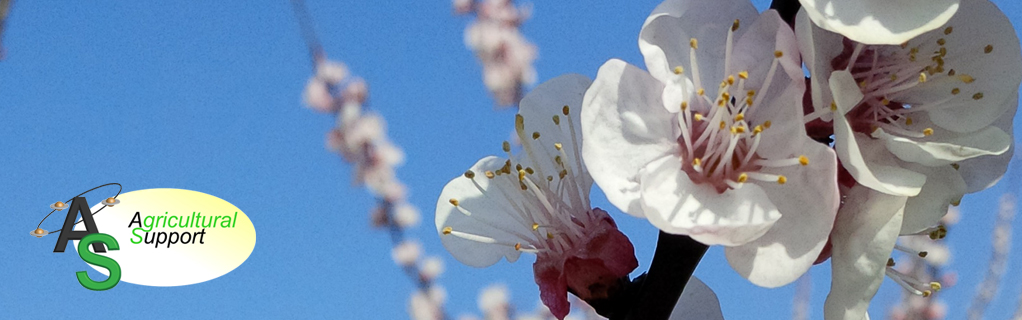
[435,0,1022,320]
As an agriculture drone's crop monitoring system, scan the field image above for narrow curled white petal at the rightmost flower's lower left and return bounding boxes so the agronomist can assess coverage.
[830,71,926,196]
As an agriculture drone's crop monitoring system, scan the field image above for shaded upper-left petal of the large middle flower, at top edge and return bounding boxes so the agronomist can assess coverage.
[639,0,758,84]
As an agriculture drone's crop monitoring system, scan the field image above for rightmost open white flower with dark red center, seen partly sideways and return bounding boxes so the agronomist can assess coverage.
[796,0,1022,233]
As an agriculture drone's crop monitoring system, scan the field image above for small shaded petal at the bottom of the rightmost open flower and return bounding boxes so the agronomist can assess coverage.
[900,164,966,234]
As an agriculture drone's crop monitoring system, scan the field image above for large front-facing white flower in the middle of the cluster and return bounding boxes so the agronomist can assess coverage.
[582,0,838,286]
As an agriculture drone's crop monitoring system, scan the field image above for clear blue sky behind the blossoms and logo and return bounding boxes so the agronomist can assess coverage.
[0,0,1022,319]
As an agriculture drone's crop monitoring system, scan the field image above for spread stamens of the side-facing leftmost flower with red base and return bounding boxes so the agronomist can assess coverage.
[442,105,598,255]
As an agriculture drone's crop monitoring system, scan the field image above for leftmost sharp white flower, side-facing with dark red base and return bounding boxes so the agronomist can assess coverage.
[436,75,639,319]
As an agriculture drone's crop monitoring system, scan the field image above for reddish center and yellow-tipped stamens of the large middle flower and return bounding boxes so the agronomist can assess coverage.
[669,19,808,192]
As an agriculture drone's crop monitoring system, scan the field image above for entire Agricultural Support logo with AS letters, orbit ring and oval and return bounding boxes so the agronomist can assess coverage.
[31,183,256,290]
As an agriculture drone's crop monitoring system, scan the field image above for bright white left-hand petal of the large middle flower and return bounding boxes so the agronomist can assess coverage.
[580,59,679,217]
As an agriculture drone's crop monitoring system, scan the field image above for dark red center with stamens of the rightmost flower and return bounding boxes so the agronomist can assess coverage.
[832,27,993,138]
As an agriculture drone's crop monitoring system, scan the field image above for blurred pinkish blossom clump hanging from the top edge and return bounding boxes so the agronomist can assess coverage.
[454,0,537,105]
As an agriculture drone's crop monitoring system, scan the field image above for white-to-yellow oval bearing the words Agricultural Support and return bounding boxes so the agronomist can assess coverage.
[69,189,256,286]
